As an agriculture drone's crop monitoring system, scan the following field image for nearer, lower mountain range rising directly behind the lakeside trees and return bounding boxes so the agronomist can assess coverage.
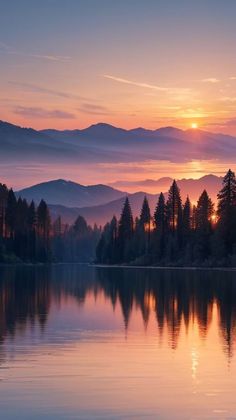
[16,175,222,225]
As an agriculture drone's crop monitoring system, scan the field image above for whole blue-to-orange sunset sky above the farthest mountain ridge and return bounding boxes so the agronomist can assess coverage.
[0,0,236,135]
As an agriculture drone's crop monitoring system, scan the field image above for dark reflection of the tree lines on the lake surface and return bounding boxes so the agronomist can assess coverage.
[0,265,236,360]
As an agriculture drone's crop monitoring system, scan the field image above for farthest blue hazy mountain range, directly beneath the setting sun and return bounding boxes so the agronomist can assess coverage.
[0,122,236,164]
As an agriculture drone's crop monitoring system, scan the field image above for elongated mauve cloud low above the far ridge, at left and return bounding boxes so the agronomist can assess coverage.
[14,106,76,119]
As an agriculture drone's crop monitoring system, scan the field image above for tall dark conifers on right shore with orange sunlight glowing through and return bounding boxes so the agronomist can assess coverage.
[96,169,236,266]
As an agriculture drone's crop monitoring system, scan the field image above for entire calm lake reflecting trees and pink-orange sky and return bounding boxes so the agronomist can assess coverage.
[0,265,236,420]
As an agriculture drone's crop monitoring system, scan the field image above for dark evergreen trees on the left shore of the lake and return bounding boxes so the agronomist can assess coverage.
[0,184,101,263]
